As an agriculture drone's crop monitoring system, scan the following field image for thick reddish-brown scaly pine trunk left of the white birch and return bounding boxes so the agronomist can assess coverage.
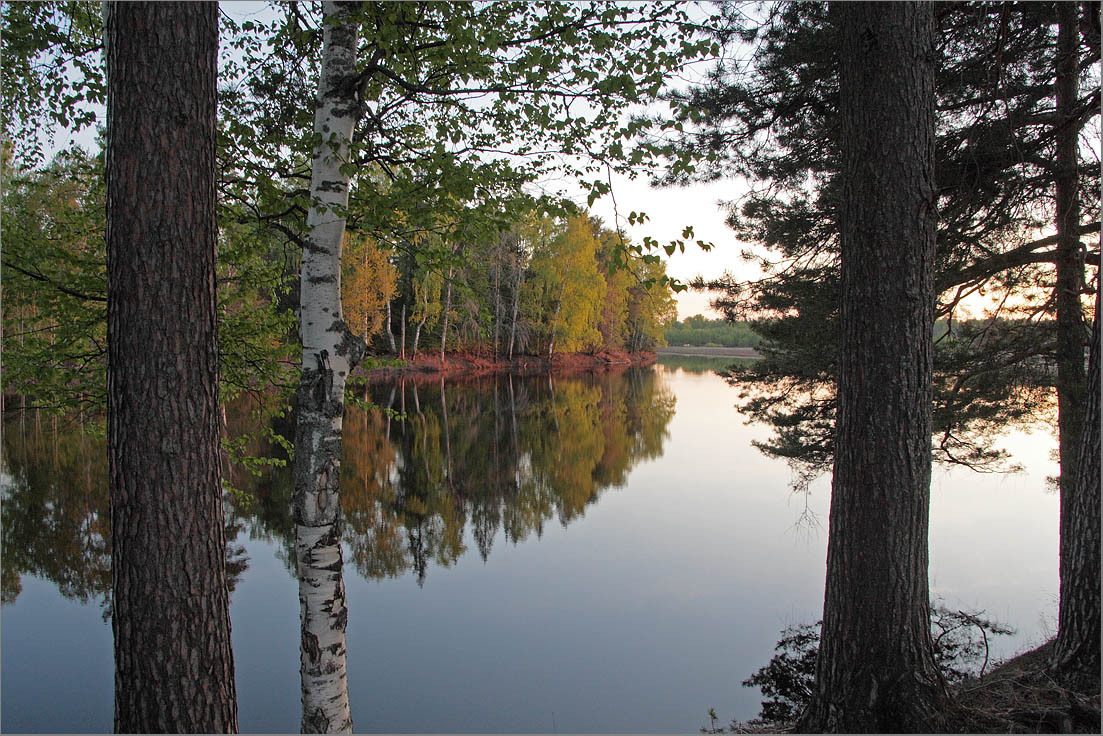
[105,2,237,733]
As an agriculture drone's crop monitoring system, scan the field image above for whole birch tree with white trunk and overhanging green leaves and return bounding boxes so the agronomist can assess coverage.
[251,2,709,730]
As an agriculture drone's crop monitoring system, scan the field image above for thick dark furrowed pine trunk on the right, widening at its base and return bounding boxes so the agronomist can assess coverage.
[799,2,946,733]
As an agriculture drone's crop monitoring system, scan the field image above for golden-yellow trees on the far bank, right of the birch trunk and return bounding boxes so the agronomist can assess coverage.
[342,212,675,360]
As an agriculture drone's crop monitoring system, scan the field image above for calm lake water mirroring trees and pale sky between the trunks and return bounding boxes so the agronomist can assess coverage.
[0,359,1058,733]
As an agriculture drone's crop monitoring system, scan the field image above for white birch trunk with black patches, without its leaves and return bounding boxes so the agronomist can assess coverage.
[292,2,365,733]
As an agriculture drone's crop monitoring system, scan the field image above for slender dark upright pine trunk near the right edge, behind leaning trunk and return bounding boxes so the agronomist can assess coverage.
[1053,2,1085,648]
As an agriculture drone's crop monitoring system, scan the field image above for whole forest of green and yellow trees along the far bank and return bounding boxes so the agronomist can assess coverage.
[3,149,674,397]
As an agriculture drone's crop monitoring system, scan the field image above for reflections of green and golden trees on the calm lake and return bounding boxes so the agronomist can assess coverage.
[2,369,674,723]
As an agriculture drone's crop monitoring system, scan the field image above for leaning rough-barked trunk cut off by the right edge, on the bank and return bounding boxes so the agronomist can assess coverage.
[1052,286,1101,687]
